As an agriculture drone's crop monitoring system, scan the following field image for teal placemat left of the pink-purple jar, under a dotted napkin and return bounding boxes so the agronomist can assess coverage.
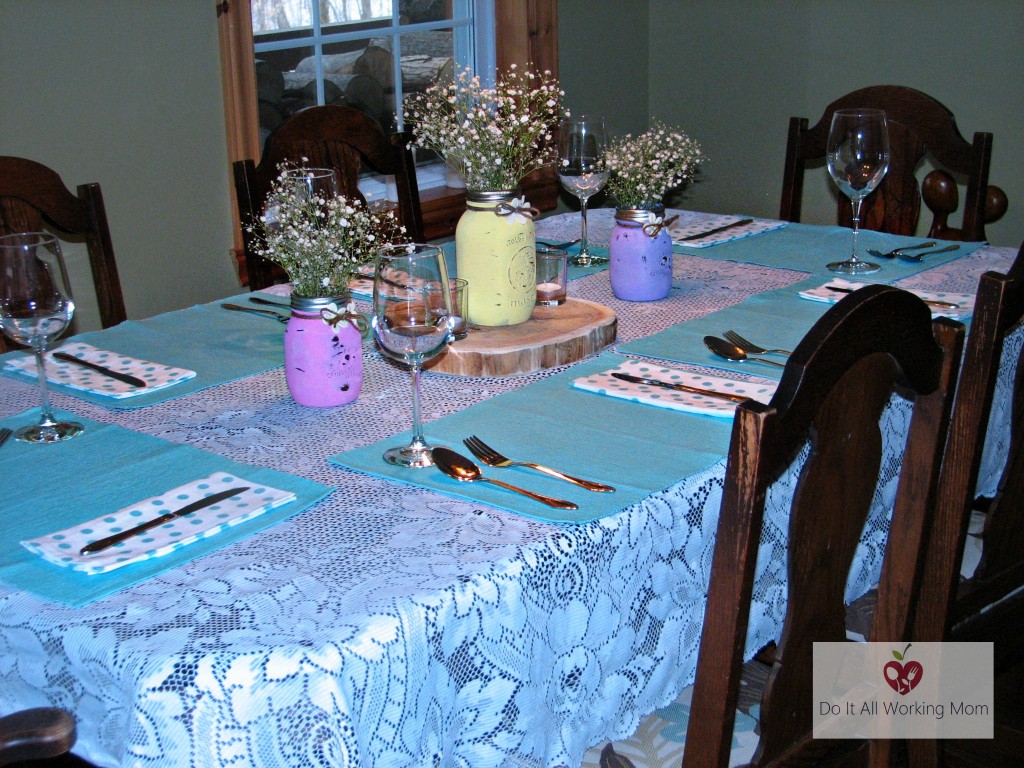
[0,293,288,409]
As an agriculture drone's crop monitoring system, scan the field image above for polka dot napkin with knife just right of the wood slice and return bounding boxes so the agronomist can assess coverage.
[572,360,778,419]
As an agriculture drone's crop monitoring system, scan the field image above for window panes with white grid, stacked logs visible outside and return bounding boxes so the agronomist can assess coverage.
[251,0,495,150]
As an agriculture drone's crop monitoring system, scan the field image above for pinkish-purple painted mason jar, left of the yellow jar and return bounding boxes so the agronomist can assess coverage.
[285,296,362,408]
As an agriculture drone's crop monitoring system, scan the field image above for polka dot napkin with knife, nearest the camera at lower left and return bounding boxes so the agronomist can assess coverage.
[22,472,295,573]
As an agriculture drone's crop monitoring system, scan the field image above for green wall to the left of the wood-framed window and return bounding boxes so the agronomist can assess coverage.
[0,0,239,330]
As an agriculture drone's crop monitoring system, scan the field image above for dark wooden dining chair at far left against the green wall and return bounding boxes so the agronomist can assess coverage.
[0,156,127,351]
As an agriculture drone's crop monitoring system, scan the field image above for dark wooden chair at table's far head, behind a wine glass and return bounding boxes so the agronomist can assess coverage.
[779,85,1007,241]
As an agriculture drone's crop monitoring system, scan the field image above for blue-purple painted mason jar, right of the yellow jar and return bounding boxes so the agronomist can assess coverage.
[608,208,672,301]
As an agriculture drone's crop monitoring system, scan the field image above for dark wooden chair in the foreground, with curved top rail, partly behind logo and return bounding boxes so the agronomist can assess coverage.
[683,286,964,768]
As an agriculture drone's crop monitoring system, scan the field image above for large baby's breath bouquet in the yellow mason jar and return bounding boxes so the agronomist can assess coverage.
[406,65,564,191]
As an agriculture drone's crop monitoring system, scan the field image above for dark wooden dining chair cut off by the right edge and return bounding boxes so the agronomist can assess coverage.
[913,239,1024,765]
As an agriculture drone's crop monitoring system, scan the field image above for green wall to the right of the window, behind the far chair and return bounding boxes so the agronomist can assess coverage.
[558,0,1024,247]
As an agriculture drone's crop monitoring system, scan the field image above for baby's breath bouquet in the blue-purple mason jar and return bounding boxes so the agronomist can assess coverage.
[605,123,703,210]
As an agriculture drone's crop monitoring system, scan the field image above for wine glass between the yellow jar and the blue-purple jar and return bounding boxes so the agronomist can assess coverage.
[558,115,608,266]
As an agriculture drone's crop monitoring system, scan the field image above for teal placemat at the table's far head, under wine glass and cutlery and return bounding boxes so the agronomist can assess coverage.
[675,223,984,283]
